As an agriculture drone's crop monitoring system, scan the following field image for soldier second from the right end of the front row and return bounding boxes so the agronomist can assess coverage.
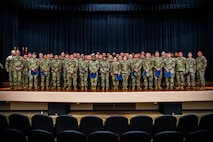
[186,52,196,89]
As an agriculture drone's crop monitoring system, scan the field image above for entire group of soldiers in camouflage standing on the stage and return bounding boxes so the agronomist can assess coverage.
[5,50,207,90]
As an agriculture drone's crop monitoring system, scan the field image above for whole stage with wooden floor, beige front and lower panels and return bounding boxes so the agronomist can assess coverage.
[0,83,213,111]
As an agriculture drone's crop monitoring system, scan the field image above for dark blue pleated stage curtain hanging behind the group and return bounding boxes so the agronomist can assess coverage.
[0,0,213,80]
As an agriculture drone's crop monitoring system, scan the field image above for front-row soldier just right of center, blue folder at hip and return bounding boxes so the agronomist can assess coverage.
[110,57,121,90]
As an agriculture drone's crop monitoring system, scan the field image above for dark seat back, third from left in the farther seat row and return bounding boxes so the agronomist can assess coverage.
[31,114,55,135]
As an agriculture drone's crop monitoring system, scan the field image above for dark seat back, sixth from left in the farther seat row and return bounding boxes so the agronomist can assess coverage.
[105,116,129,135]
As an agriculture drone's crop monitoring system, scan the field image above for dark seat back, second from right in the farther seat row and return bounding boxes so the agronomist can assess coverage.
[177,114,198,137]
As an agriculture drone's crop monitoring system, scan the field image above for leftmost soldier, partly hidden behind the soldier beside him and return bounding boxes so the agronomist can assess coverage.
[5,50,16,89]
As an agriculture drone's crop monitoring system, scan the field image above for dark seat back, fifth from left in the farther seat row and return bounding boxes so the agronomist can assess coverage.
[79,116,103,135]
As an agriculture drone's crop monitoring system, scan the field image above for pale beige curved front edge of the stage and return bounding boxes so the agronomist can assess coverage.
[0,90,213,103]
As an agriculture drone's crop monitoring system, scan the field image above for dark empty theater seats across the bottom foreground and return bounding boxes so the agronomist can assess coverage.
[0,114,213,142]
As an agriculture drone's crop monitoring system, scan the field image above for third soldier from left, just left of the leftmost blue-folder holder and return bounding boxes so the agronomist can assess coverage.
[22,54,29,89]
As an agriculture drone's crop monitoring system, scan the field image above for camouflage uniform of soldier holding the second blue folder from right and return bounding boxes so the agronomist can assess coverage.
[153,57,164,89]
